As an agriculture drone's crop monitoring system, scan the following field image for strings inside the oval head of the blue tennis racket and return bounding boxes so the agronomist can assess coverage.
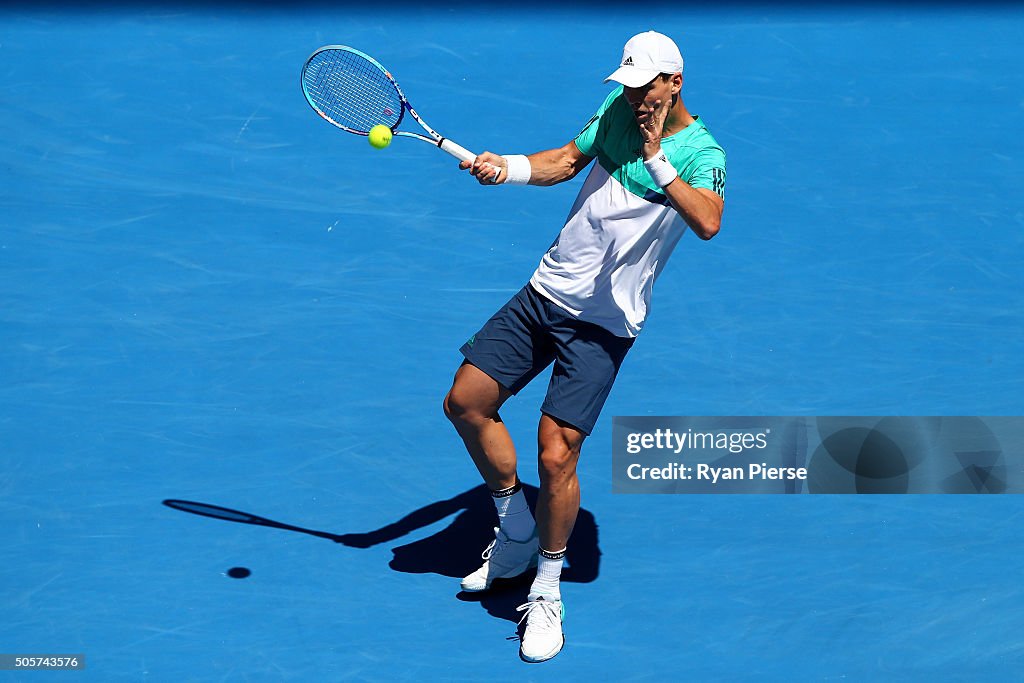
[302,49,402,133]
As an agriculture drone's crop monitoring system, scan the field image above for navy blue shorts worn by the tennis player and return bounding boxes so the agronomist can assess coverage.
[460,285,635,435]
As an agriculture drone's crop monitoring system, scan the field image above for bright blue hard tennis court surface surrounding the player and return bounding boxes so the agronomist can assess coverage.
[0,3,1024,681]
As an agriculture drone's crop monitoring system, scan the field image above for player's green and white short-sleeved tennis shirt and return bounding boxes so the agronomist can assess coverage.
[529,87,725,337]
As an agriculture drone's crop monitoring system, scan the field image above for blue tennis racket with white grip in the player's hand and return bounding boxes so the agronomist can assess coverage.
[302,45,476,162]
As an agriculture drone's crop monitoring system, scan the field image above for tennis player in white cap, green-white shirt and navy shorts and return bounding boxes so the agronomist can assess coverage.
[444,31,725,661]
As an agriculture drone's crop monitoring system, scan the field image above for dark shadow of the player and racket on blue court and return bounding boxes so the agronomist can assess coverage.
[163,484,601,622]
